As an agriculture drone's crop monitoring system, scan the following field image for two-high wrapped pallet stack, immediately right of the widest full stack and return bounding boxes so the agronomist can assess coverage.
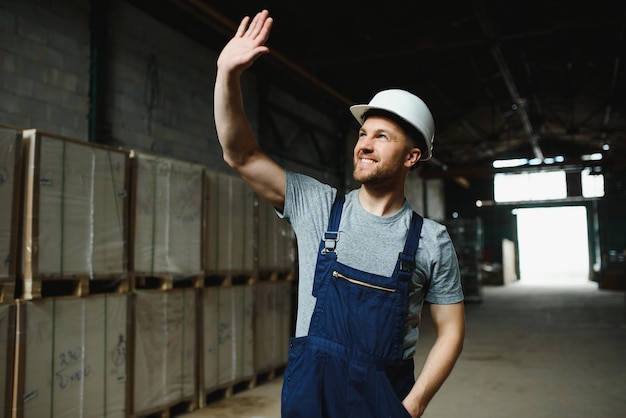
[129,152,205,416]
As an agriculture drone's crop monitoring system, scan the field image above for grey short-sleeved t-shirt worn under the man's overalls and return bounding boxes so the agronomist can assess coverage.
[279,171,463,359]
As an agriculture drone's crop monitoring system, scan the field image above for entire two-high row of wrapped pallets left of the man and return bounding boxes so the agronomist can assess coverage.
[0,127,295,418]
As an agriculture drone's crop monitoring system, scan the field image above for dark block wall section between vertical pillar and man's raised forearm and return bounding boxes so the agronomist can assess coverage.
[108,1,234,167]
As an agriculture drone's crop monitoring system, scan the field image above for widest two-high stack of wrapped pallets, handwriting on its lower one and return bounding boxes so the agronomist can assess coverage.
[7,130,129,417]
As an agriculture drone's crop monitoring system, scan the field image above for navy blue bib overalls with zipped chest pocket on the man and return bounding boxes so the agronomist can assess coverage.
[282,196,423,418]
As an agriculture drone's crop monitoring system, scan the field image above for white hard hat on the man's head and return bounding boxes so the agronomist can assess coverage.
[350,89,435,161]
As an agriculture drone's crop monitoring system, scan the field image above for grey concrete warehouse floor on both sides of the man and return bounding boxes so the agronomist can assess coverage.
[178,282,626,418]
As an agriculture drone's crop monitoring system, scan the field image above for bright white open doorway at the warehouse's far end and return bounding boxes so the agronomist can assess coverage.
[516,206,589,285]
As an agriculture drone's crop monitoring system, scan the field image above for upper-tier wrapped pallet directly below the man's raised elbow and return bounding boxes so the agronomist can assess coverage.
[205,171,256,276]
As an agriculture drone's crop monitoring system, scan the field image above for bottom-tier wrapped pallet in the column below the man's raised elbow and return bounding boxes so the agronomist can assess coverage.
[200,286,255,393]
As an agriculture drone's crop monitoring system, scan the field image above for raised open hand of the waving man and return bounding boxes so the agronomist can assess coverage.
[217,10,273,73]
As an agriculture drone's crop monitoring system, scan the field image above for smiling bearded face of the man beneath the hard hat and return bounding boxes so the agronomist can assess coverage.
[353,116,421,186]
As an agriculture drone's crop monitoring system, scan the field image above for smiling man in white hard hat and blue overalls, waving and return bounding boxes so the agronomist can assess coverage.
[215,10,465,418]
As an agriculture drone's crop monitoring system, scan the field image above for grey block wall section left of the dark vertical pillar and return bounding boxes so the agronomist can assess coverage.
[0,0,89,139]
